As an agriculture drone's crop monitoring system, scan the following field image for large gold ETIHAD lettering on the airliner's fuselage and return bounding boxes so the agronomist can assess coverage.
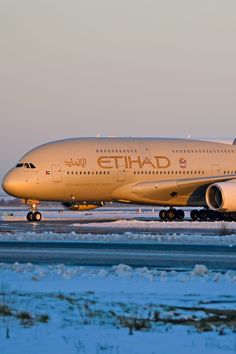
[97,155,171,169]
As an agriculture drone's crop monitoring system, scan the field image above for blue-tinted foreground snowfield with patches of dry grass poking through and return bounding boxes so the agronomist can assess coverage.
[0,263,236,354]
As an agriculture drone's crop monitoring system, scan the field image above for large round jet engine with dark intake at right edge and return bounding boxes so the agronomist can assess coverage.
[206,180,236,212]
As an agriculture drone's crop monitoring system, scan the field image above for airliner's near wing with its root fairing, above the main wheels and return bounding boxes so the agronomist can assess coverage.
[113,175,236,205]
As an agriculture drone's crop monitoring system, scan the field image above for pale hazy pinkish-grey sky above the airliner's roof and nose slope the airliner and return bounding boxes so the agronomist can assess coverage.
[0,0,236,189]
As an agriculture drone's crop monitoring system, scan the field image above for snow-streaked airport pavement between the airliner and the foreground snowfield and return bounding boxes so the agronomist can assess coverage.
[0,208,236,270]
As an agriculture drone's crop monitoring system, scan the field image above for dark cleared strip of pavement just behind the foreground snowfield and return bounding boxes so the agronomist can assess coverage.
[0,241,236,270]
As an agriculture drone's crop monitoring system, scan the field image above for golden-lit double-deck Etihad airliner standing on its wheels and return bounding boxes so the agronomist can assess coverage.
[2,138,236,221]
